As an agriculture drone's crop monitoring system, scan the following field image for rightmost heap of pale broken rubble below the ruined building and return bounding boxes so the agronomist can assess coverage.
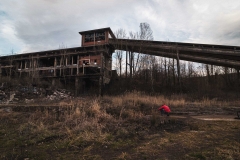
[46,89,72,101]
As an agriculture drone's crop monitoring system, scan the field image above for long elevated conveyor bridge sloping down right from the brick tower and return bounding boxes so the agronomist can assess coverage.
[109,39,240,69]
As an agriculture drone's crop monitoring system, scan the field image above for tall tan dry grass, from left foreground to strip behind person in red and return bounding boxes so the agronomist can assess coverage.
[19,91,239,145]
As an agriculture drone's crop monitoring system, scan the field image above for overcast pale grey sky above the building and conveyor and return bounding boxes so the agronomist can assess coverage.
[0,0,240,55]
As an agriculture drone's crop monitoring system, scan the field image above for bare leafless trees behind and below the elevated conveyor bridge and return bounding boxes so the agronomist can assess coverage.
[108,23,240,95]
